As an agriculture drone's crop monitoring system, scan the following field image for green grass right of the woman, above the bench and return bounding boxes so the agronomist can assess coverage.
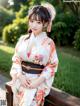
[53,48,80,97]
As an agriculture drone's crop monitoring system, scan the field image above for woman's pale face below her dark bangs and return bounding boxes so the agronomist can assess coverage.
[29,15,43,35]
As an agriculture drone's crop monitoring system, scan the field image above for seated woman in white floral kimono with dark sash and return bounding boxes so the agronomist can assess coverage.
[10,4,58,106]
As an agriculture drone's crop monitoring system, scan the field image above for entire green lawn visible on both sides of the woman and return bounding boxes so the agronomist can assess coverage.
[0,45,80,97]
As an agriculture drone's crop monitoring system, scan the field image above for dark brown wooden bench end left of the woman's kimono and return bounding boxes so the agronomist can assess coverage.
[5,84,13,106]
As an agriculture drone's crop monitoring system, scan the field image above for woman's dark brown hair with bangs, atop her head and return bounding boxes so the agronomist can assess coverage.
[28,5,51,23]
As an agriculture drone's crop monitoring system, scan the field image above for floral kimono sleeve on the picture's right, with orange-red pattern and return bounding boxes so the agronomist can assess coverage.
[41,41,58,80]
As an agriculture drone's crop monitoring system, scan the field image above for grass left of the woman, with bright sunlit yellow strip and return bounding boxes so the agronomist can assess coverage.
[0,45,14,74]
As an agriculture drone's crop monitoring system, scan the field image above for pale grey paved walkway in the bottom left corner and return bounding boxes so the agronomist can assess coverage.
[0,74,9,106]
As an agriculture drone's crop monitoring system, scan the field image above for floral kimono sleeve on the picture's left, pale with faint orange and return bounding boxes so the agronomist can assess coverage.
[10,36,23,77]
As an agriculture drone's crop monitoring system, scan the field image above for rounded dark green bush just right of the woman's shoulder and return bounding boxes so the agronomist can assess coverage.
[52,22,67,46]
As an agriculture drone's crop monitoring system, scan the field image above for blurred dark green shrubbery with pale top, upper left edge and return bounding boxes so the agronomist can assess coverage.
[0,6,15,36]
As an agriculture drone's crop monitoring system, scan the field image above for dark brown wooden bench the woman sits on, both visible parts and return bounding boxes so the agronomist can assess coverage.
[5,84,80,106]
